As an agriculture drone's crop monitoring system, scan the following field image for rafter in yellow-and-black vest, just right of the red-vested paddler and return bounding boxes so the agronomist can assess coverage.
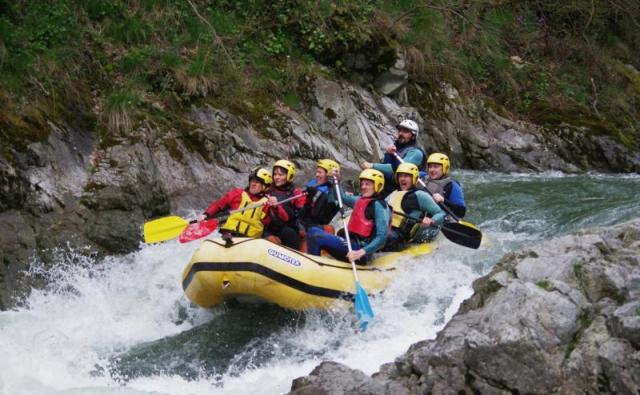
[384,162,447,251]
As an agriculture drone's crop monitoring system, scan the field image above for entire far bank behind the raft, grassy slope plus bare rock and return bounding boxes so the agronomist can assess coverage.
[0,0,640,310]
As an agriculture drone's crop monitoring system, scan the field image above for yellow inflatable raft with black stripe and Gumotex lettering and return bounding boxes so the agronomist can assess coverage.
[182,238,434,310]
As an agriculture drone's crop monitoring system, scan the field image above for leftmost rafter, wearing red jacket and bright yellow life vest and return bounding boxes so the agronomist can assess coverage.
[197,168,286,237]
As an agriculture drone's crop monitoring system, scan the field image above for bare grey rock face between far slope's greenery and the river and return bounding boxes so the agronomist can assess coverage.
[0,74,640,309]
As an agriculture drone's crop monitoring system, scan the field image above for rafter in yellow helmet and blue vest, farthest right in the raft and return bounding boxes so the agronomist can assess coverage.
[426,152,467,218]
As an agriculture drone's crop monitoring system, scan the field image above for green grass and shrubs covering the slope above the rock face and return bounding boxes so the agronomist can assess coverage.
[0,0,640,153]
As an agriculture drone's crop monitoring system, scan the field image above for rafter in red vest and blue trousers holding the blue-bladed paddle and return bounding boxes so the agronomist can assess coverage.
[306,169,390,264]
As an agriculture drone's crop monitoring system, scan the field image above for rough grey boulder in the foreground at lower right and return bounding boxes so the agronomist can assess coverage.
[292,220,640,394]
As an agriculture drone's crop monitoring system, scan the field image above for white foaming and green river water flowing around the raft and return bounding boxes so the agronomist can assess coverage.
[0,172,640,395]
